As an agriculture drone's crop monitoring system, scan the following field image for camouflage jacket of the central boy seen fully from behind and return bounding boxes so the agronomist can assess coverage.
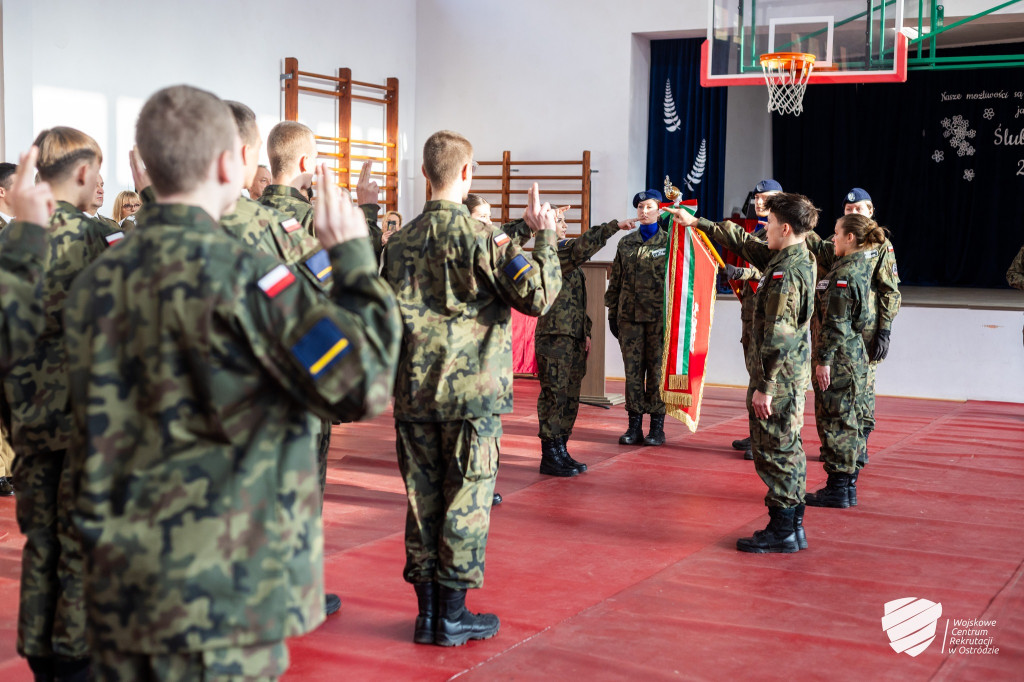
[383,201,562,419]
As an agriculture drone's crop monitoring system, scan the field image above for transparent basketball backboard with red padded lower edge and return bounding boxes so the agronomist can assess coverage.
[700,0,907,87]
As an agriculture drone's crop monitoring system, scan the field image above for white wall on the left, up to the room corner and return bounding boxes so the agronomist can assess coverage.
[2,0,418,213]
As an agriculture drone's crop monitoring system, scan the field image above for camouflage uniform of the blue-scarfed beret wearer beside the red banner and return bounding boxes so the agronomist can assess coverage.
[604,229,669,415]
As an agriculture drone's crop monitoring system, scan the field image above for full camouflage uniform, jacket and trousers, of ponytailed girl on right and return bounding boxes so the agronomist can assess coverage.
[813,250,878,474]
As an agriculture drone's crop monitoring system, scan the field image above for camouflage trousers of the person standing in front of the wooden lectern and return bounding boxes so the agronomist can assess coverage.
[535,334,587,440]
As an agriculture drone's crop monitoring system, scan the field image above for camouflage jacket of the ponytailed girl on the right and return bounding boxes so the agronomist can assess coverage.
[814,251,878,377]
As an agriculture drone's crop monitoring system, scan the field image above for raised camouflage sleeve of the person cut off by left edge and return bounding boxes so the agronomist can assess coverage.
[0,220,49,377]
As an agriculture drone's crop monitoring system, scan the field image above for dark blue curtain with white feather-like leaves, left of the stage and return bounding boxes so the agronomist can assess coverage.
[647,38,728,220]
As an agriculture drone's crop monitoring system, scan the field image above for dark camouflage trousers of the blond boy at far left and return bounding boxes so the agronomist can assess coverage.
[14,451,89,658]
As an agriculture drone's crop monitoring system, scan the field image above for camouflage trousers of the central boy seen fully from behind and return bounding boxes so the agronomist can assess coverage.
[394,415,502,590]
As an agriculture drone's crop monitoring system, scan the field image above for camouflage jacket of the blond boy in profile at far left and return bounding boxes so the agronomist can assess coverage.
[4,202,117,456]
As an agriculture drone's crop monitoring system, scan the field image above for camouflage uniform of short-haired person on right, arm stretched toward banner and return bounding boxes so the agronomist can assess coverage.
[697,218,814,509]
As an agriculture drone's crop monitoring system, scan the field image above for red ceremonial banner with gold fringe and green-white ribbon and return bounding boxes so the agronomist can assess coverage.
[662,210,718,433]
